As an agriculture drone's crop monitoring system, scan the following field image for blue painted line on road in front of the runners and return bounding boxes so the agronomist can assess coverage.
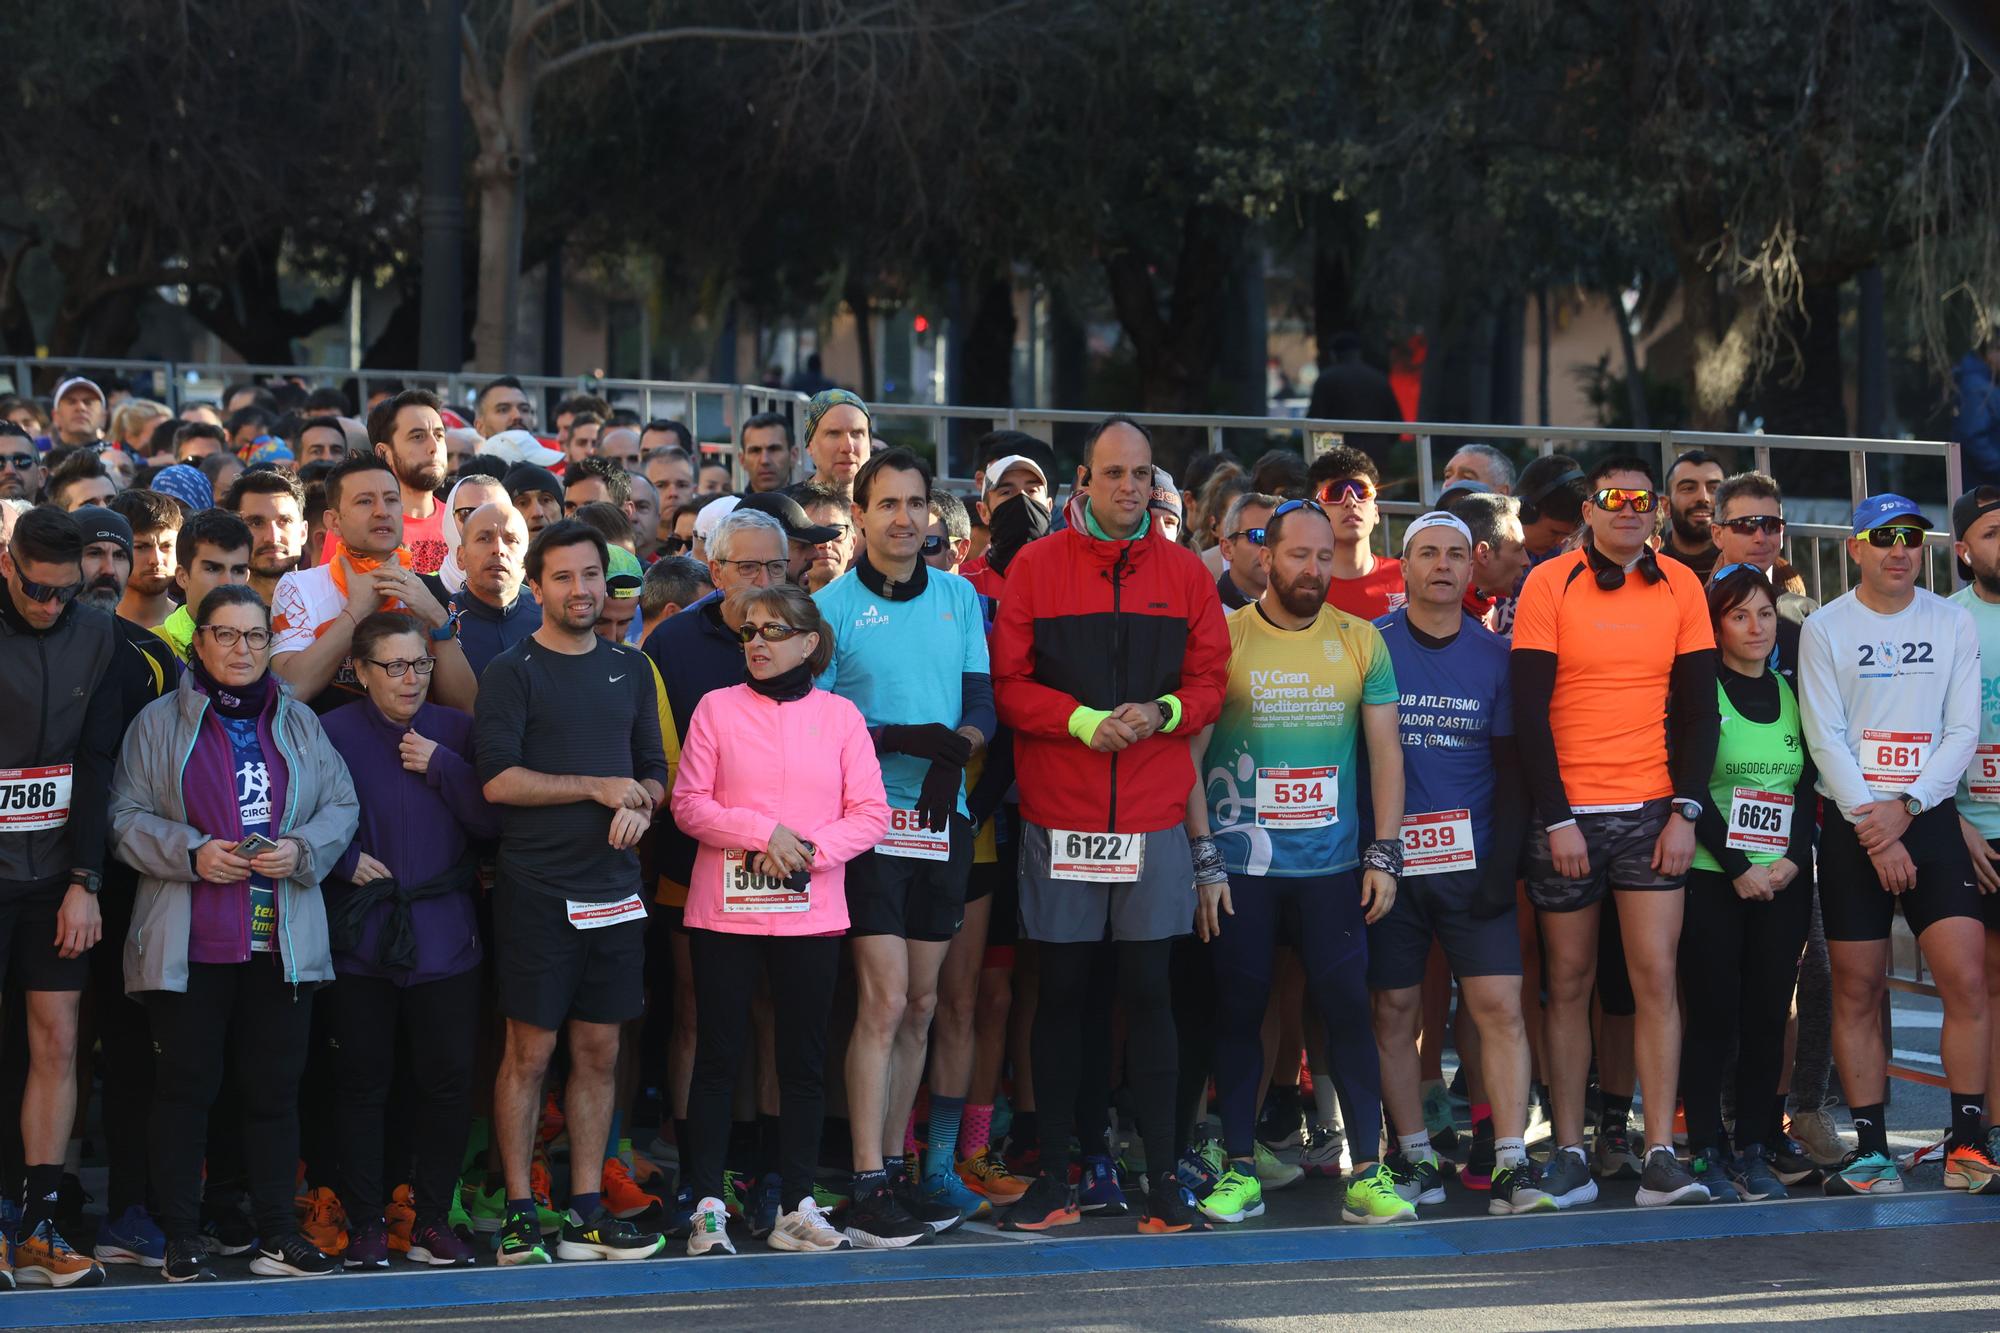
[15,1195,2000,1329]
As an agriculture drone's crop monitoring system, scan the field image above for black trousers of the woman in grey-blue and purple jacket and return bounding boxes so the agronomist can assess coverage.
[146,953,312,1245]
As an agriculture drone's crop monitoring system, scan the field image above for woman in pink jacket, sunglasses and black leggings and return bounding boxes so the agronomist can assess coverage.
[674,584,888,1255]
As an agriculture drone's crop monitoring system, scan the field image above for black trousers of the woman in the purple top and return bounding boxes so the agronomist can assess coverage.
[332,967,482,1227]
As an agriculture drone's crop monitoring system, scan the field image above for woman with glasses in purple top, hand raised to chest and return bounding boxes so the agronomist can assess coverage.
[324,610,500,1269]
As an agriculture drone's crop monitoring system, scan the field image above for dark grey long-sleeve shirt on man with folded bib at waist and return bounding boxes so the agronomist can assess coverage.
[472,638,666,903]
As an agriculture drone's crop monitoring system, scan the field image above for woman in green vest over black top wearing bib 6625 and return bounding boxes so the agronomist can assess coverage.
[1680,564,1814,1201]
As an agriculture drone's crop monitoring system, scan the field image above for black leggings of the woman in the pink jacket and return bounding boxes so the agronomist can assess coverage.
[684,931,840,1213]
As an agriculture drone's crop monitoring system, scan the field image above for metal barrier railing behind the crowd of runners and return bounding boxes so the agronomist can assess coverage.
[0,358,1962,1083]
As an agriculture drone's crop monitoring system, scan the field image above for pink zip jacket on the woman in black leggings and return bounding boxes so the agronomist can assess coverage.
[674,685,888,935]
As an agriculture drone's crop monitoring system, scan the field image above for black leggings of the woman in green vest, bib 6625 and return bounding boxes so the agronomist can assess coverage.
[1680,871,1812,1151]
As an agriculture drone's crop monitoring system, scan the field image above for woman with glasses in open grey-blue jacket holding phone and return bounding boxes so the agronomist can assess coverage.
[112,584,358,1283]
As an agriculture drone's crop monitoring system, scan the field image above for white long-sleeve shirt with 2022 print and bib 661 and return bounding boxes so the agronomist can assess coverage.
[1798,588,1980,821]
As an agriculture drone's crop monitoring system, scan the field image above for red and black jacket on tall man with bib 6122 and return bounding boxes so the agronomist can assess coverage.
[992,496,1230,833]
